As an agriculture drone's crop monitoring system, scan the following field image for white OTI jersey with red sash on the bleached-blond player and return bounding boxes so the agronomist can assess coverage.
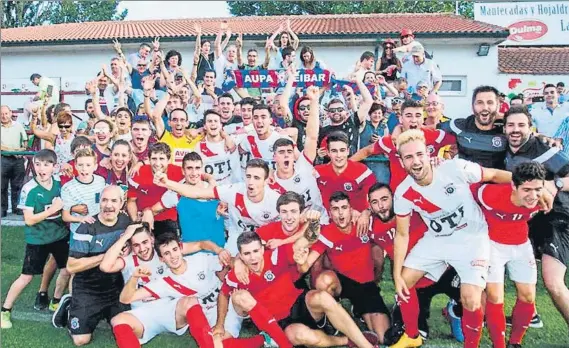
[394,159,488,239]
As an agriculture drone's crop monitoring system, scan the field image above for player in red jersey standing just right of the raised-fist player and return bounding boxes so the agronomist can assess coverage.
[314,131,375,212]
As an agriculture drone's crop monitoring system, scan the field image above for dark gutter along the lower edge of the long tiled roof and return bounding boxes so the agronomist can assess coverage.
[0,30,510,47]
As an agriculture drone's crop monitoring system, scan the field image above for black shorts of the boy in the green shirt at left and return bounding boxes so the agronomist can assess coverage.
[22,237,69,275]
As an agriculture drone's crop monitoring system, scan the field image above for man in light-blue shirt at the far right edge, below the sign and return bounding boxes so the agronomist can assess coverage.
[531,84,569,137]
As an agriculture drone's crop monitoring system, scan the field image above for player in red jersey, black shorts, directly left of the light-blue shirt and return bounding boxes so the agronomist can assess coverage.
[126,143,184,236]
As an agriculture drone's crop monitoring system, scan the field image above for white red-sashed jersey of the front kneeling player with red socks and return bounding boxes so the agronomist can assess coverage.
[144,253,222,312]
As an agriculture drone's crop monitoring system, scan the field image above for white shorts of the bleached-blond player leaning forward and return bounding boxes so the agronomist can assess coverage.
[403,235,490,288]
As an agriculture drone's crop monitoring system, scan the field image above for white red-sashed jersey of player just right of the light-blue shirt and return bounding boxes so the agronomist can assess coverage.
[214,183,280,235]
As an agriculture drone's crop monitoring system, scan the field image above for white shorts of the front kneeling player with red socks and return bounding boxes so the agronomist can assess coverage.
[127,298,188,344]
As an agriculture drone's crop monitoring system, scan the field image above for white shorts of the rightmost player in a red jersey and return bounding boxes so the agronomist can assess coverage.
[488,240,537,284]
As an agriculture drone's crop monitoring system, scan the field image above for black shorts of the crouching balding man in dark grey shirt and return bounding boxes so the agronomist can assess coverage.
[67,289,130,335]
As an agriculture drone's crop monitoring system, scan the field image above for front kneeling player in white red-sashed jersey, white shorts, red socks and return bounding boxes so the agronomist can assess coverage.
[113,233,241,348]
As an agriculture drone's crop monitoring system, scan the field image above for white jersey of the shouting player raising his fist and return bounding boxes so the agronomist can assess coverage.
[271,152,329,225]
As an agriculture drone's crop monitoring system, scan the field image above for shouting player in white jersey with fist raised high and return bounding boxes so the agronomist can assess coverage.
[271,86,328,225]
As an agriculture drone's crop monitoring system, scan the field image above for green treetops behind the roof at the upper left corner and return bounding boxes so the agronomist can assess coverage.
[2,0,128,28]
